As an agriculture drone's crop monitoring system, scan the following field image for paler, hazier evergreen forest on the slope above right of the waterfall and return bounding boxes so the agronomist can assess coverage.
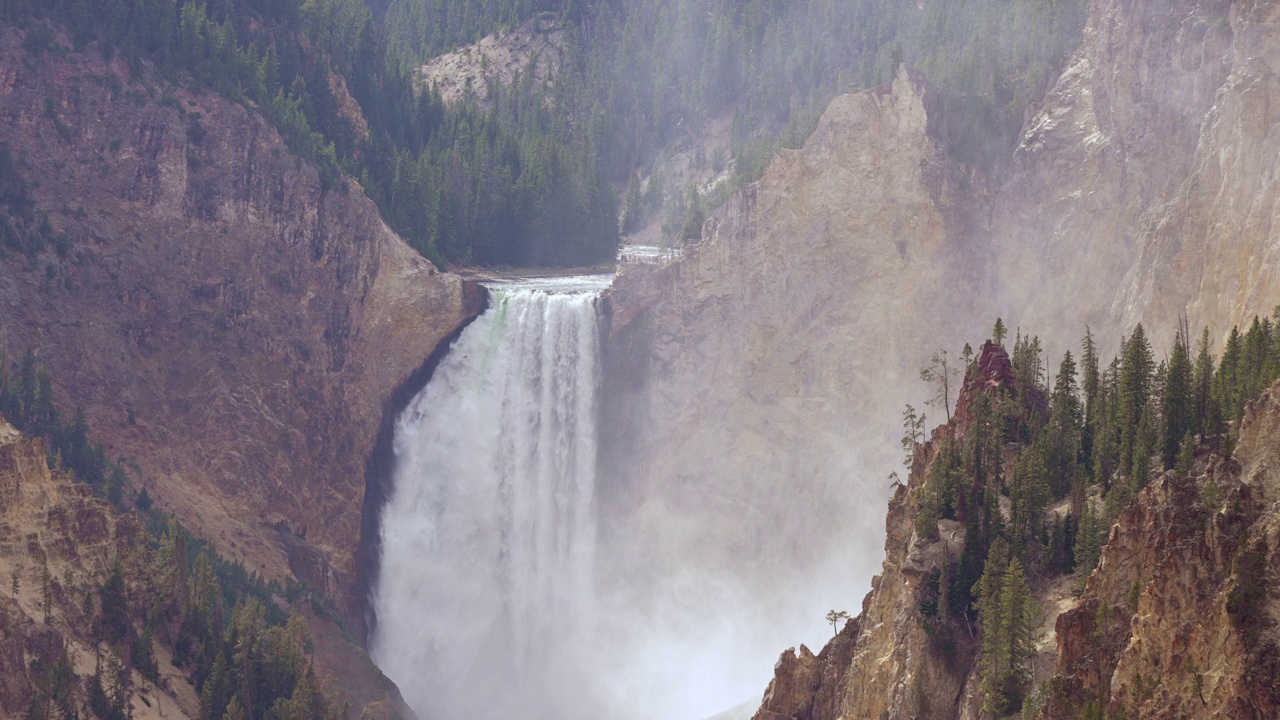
[384,0,1087,238]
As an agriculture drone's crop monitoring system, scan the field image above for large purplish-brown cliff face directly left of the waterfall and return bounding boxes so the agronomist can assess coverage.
[0,31,484,632]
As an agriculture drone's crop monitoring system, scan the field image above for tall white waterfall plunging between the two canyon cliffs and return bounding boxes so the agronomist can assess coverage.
[371,279,604,720]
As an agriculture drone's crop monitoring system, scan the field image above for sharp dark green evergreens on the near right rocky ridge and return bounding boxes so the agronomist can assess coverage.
[902,307,1280,717]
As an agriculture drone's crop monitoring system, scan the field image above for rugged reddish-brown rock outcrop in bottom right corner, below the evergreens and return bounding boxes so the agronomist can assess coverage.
[1041,384,1280,719]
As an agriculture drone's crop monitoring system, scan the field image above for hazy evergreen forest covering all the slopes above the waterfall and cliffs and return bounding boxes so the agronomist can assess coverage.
[0,0,1085,265]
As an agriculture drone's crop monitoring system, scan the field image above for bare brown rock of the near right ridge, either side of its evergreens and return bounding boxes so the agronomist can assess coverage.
[755,346,1280,720]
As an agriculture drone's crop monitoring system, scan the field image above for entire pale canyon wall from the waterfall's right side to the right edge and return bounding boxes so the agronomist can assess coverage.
[605,0,1280,717]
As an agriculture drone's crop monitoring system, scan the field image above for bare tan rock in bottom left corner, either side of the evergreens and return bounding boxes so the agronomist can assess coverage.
[0,418,412,720]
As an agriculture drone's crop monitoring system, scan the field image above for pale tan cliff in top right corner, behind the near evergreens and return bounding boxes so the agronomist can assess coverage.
[989,0,1280,345]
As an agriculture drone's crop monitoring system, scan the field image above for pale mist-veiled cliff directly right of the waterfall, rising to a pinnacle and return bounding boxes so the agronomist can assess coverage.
[602,69,983,661]
